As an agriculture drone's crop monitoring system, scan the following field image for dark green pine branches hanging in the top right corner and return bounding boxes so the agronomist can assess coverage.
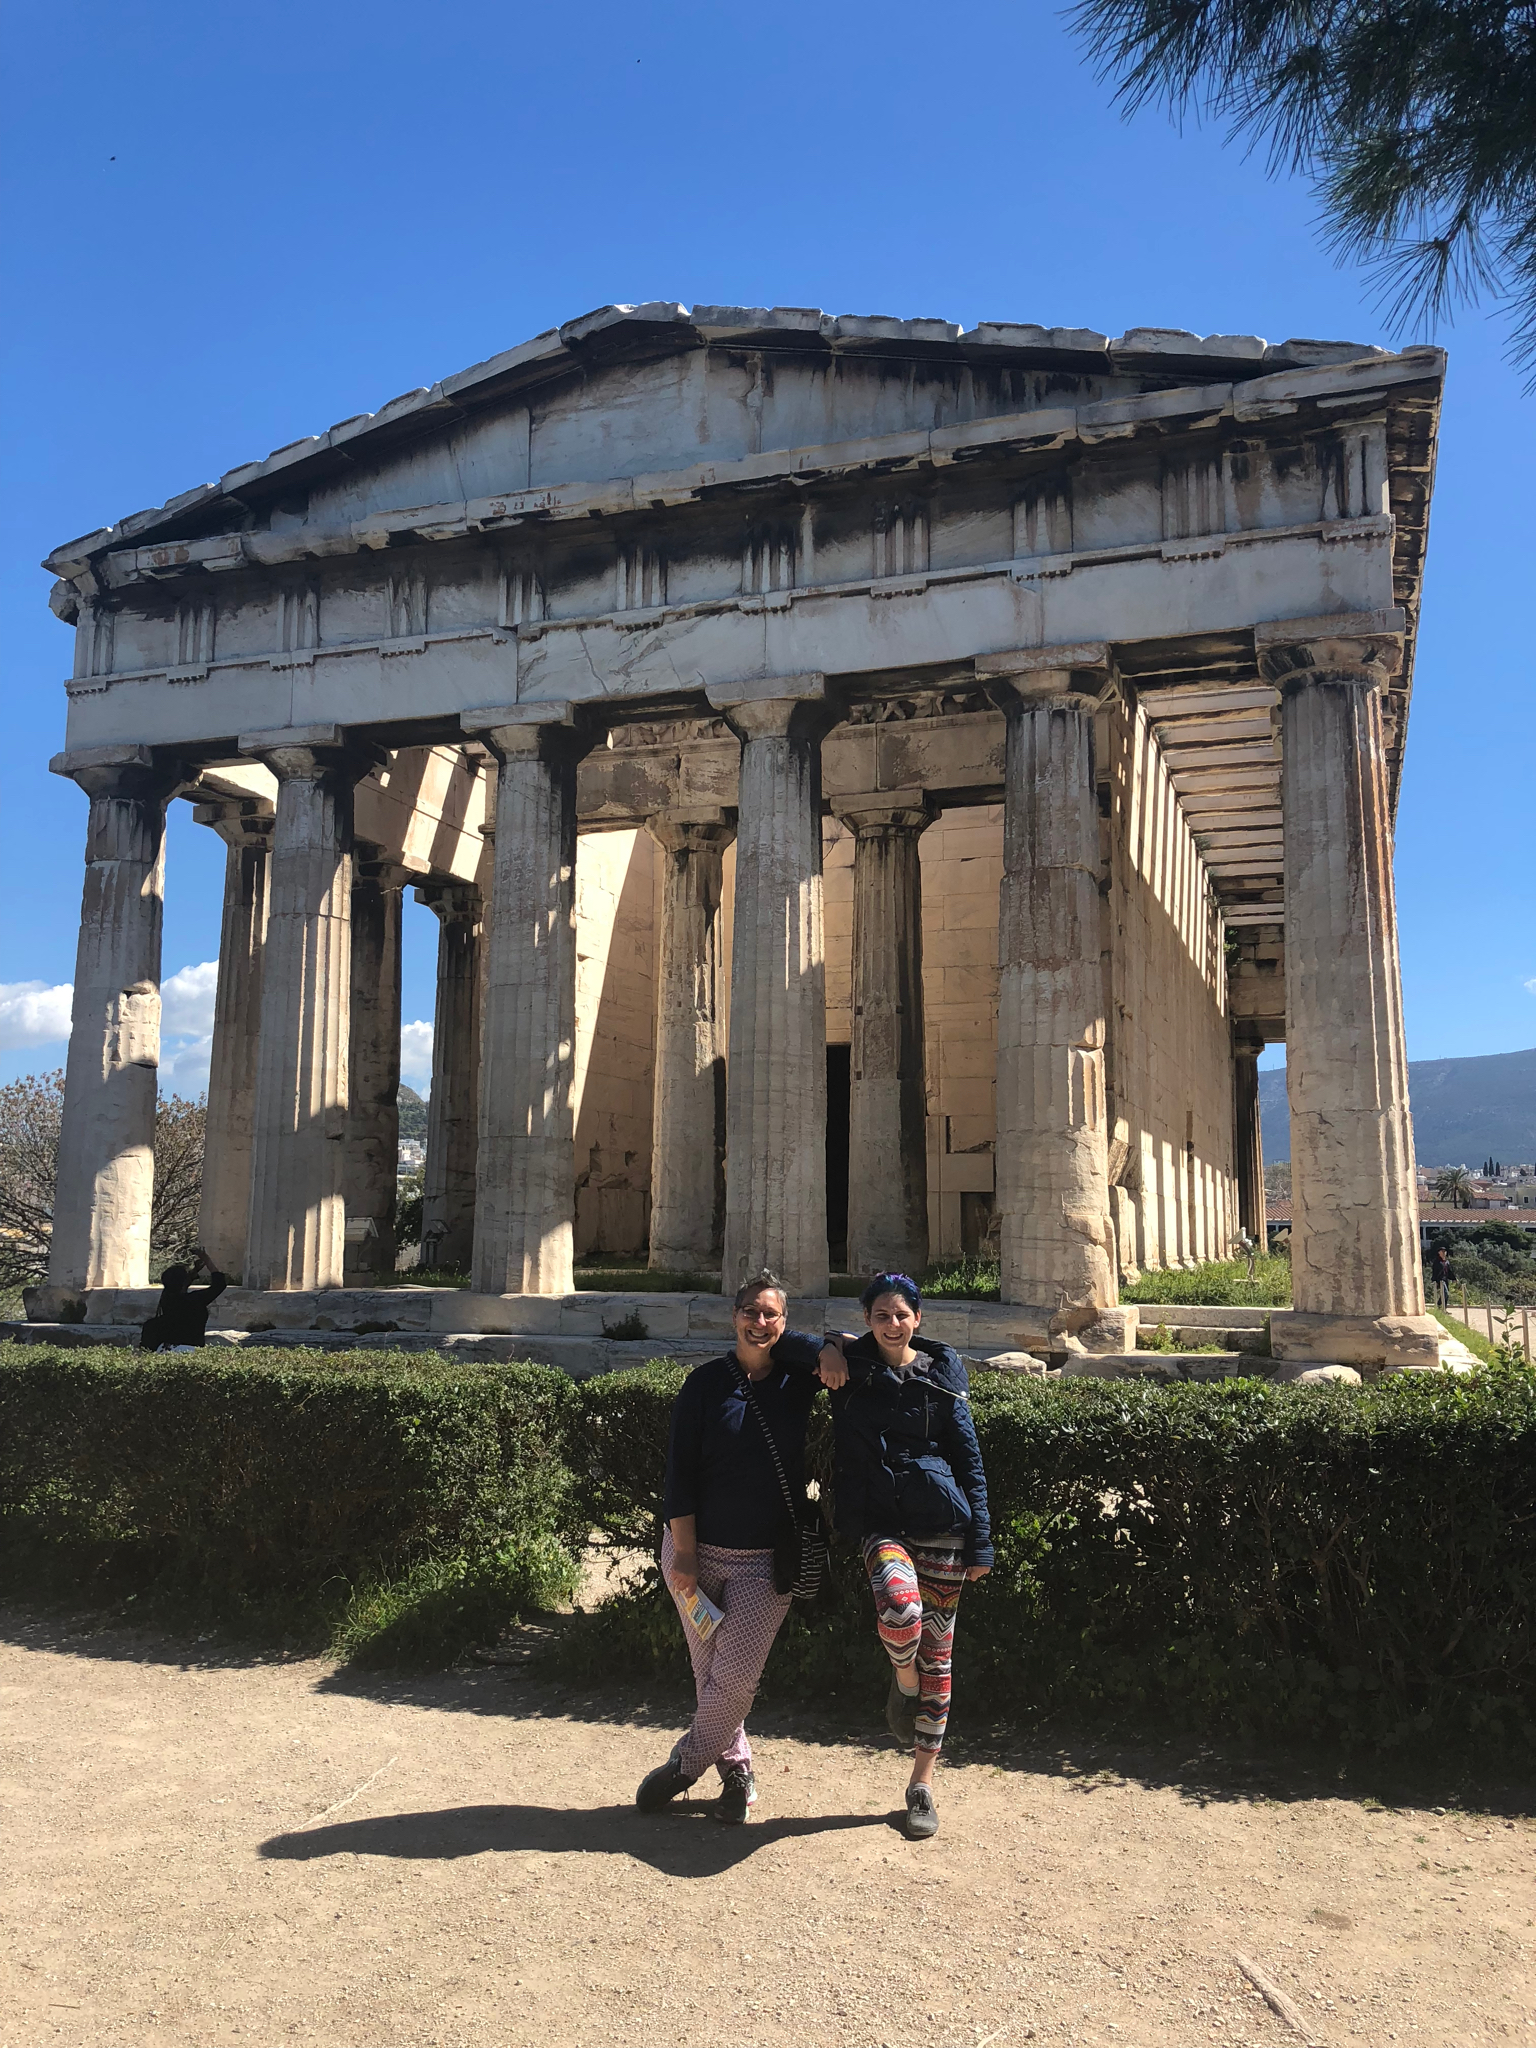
[1069,0,1536,367]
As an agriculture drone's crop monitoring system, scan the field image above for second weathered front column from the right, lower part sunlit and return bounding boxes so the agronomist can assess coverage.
[977,649,1118,1331]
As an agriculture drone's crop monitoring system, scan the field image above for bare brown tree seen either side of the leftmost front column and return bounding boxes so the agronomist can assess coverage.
[0,1069,207,1288]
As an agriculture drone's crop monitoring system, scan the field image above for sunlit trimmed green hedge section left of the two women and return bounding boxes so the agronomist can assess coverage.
[0,1343,586,1661]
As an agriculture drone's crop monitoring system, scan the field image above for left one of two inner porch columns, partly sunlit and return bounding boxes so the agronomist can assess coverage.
[649,811,735,1272]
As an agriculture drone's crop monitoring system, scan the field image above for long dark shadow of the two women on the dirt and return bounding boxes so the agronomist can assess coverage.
[260,1800,899,1878]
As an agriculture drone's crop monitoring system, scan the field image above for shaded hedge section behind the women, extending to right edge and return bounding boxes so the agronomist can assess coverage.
[569,1366,1536,1749]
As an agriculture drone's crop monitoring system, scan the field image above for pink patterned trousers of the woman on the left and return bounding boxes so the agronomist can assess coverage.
[662,1530,791,1778]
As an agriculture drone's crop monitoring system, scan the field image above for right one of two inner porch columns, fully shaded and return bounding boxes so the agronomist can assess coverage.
[836,788,934,1274]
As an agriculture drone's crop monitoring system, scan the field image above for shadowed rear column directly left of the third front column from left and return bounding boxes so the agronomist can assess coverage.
[416,883,481,1272]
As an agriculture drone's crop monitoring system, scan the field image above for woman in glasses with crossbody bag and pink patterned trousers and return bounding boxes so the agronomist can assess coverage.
[635,1272,848,1825]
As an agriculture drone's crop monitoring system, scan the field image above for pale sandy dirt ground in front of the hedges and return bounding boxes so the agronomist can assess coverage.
[0,1616,1536,2048]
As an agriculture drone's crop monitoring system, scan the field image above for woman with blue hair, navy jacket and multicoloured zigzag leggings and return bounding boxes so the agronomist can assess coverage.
[831,1274,991,1841]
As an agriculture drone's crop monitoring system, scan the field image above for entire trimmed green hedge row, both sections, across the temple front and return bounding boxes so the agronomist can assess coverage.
[0,1346,1536,1749]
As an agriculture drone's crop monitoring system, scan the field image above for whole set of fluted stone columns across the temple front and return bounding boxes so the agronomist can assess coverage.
[55,614,1421,1317]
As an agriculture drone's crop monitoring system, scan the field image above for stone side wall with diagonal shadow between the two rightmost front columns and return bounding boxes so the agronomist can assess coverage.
[1098,707,1237,1276]
